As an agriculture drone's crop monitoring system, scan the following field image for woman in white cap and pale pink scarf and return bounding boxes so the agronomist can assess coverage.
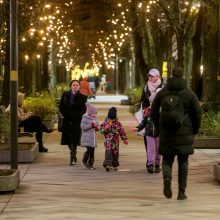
[140,69,163,169]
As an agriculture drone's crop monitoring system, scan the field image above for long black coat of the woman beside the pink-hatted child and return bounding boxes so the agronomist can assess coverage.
[59,91,87,146]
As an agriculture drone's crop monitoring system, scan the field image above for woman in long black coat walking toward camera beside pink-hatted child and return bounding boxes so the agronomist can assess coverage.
[59,80,87,165]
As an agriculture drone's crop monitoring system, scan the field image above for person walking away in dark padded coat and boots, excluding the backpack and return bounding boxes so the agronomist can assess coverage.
[151,68,201,200]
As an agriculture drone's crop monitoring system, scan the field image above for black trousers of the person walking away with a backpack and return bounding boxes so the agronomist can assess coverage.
[162,154,189,192]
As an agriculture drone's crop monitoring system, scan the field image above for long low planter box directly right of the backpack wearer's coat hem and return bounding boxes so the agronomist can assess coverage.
[193,137,220,149]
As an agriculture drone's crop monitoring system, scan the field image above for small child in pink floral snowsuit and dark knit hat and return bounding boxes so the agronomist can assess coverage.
[100,107,128,172]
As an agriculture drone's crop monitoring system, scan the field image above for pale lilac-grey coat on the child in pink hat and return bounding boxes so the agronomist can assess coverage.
[80,114,98,147]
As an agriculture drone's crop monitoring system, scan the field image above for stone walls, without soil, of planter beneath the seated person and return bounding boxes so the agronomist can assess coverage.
[0,143,39,163]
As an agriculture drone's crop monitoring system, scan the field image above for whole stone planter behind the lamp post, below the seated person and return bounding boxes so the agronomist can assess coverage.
[0,142,39,163]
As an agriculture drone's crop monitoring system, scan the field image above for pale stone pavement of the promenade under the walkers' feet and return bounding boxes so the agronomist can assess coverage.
[0,104,220,220]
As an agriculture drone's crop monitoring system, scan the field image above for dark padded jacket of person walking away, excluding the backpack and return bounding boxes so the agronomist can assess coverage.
[151,77,201,155]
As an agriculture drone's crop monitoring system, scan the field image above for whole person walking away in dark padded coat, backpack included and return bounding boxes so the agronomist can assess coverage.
[151,67,201,200]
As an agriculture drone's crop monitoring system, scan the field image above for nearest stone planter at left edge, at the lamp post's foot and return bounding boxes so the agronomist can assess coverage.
[0,170,20,192]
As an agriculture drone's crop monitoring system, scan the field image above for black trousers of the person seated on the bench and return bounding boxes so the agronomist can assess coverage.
[18,116,45,146]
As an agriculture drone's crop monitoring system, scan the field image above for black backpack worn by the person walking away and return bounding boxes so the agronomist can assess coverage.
[160,91,187,130]
